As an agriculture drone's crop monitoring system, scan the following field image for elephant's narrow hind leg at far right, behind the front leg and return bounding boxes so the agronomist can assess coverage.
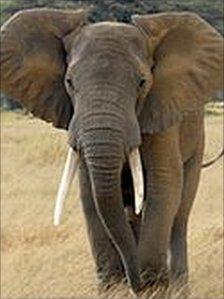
[170,147,203,283]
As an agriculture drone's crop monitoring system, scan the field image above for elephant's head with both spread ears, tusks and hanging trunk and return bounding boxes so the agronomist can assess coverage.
[1,9,223,290]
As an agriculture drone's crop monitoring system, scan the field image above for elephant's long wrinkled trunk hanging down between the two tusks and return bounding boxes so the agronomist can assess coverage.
[83,129,140,291]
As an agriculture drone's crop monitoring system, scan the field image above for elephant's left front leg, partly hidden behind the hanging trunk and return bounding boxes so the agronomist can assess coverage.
[79,162,125,290]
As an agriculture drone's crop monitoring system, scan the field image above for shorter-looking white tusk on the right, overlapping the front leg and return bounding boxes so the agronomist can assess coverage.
[129,148,144,215]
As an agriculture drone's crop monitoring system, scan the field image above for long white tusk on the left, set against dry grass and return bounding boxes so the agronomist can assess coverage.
[54,147,79,226]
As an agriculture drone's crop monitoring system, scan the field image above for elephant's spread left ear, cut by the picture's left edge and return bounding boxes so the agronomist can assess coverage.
[0,9,85,129]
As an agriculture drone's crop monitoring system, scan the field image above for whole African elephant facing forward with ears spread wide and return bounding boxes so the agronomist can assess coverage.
[1,9,223,292]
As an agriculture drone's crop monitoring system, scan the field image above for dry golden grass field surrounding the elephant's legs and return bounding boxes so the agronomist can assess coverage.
[1,112,223,299]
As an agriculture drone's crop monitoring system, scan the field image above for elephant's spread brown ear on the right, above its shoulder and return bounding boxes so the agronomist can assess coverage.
[133,13,223,133]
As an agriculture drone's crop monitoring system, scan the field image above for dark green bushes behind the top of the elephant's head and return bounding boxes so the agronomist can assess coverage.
[1,0,223,33]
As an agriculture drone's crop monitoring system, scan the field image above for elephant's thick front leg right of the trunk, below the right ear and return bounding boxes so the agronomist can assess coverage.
[139,128,183,286]
